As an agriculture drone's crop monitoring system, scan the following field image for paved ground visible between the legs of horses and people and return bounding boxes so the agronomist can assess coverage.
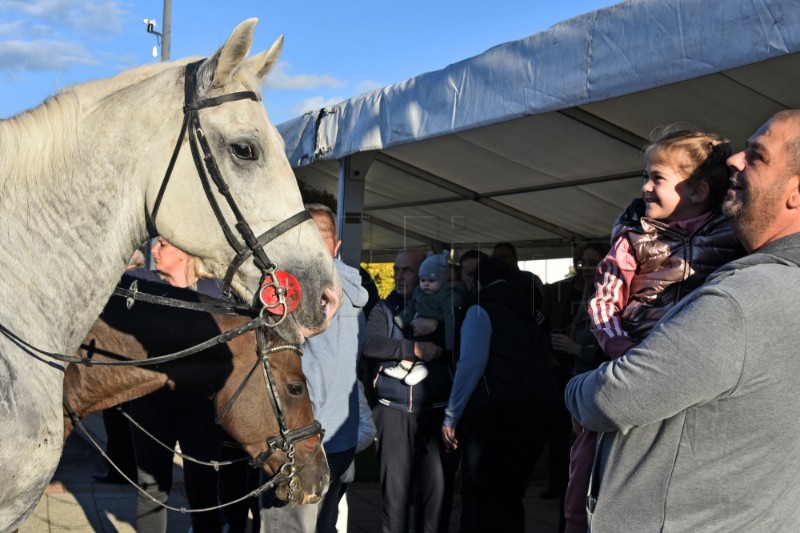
[19,414,558,533]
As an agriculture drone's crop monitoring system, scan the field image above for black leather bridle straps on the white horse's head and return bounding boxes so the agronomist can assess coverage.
[147,61,311,300]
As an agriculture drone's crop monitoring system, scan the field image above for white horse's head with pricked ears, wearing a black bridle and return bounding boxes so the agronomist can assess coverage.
[146,19,341,342]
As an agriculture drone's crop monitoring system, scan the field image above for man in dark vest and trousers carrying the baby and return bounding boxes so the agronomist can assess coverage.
[363,250,452,533]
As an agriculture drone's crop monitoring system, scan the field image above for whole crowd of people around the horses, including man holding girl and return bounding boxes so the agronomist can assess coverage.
[90,110,800,533]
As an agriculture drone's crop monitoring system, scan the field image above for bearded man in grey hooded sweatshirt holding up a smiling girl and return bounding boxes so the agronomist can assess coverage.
[566,110,800,532]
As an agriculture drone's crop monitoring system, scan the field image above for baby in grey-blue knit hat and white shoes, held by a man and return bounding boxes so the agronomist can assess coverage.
[383,250,467,385]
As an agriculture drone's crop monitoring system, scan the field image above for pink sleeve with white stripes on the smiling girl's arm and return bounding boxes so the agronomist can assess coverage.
[589,237,636,359]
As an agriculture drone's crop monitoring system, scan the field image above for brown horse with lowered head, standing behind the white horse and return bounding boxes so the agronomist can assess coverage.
[59,276,328,503]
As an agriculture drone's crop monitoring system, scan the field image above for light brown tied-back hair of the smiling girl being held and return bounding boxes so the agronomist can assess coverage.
[644,124,731,210]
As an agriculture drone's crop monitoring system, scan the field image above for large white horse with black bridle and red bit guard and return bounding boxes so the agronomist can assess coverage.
[0,19,341,531]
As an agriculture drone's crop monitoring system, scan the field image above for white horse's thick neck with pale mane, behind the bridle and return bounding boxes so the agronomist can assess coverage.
[0,71,179,351]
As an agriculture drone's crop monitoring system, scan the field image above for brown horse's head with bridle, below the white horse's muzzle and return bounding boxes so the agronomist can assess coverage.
[214,326,329,503]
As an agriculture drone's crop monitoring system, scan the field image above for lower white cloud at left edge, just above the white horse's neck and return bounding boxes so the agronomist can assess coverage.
[0,40,98,71]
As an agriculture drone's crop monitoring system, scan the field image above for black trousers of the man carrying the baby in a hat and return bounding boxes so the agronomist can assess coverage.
[373,403,454,533]
